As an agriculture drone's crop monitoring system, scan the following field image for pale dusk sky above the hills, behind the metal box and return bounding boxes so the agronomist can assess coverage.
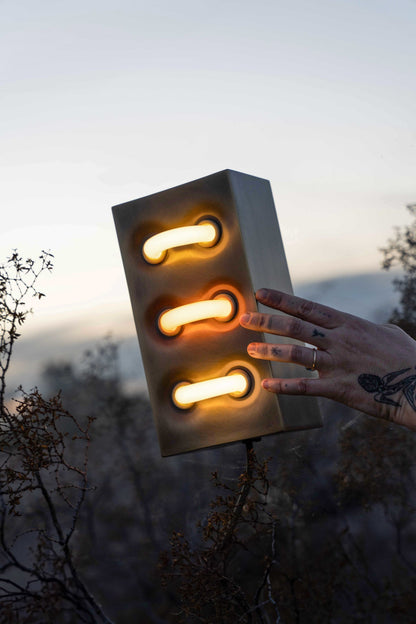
[0,0,416,342]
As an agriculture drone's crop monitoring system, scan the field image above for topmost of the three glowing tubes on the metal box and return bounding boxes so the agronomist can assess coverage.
[142,220,219,264]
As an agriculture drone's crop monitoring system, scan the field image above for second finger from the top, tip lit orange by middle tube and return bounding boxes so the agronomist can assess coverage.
[240,312,329,348]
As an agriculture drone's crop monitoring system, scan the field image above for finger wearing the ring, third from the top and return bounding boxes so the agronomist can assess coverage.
[247,342,329,370]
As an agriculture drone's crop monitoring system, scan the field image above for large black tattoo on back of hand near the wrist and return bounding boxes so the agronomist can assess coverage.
[358,367,416,412]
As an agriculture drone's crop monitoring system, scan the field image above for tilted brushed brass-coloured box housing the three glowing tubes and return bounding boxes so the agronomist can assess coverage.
[113,170,320,455]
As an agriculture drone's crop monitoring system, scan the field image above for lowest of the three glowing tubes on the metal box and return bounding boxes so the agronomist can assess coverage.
[172,371,251,409]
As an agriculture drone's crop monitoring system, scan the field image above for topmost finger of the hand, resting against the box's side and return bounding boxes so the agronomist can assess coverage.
[256,288,349,329]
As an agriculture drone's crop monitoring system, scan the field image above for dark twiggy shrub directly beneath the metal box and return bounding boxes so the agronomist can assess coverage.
[161,442,279,624]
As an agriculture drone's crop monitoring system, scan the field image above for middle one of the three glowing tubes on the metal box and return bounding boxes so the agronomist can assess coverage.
[158,294,236,336]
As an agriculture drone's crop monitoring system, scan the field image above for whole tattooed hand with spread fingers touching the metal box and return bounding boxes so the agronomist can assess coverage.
[240,288,416,430]
